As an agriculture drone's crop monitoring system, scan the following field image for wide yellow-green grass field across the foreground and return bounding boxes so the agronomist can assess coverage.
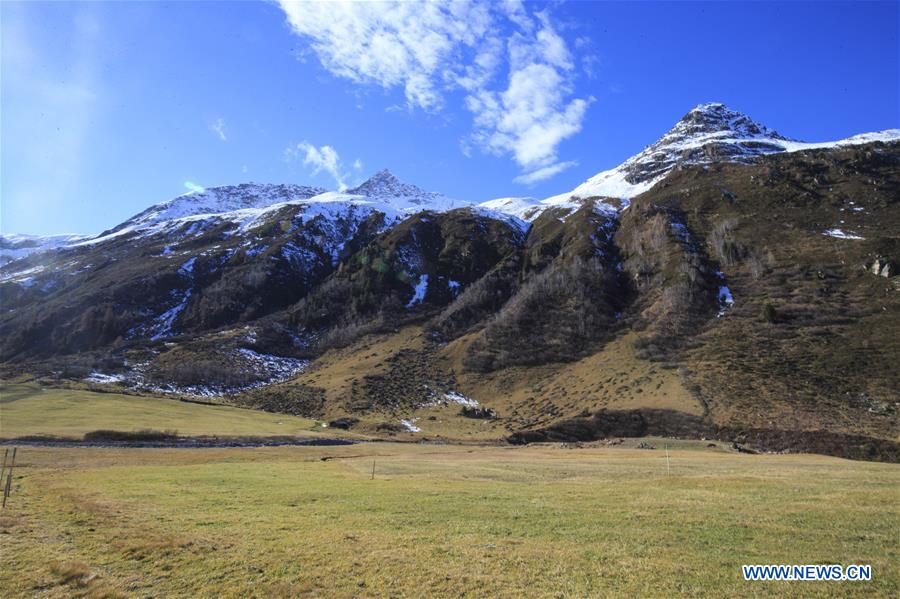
[0,442,900,597]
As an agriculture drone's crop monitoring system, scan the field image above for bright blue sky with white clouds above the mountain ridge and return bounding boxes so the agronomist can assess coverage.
[0,1,900,234]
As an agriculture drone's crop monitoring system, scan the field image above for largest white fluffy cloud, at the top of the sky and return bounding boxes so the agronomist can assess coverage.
[279,0,593,181]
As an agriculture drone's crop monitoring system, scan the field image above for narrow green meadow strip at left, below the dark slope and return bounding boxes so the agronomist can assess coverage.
[0,383,324,439]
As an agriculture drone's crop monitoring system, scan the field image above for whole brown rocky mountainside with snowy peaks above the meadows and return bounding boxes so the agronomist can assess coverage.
[0,104,900,459]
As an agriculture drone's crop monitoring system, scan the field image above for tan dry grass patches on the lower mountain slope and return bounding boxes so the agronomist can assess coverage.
[251,327,704,439]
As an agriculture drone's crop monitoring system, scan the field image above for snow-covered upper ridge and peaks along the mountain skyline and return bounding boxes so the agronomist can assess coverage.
[0,103,900,263]
